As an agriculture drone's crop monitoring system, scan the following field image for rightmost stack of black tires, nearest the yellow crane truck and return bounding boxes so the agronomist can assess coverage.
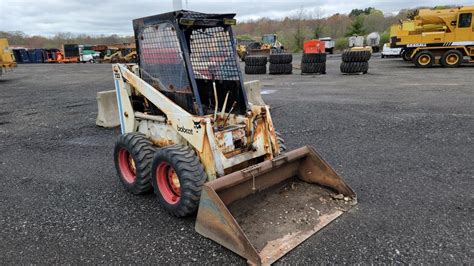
[341,50,372,74]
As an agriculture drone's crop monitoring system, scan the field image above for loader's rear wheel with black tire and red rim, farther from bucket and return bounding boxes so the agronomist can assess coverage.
[114,133,156,195]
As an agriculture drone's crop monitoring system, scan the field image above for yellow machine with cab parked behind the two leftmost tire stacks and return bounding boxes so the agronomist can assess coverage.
[239,34,285,60]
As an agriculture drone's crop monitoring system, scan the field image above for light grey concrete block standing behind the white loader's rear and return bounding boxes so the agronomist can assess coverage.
[95,90,120,127]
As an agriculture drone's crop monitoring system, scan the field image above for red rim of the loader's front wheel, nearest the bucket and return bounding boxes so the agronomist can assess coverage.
[156,162,181,204]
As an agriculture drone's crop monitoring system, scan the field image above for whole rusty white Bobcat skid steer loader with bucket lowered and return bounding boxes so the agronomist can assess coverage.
[112,10,356,264]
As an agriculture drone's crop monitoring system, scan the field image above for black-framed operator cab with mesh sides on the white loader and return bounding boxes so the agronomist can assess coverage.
[133,10,248,115]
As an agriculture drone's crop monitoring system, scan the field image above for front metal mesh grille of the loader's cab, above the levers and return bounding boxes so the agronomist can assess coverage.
[190,27,239,80]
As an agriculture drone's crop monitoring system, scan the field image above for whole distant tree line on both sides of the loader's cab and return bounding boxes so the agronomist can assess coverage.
[0,6,460,52]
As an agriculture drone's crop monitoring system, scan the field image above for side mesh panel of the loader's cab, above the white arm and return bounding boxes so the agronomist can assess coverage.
[139,23,191,93]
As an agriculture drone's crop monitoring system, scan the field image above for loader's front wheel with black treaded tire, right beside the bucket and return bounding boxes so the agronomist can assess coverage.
[151,145,207,217]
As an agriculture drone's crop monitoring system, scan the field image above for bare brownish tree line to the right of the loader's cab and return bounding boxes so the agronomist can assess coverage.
[234,6,455,52]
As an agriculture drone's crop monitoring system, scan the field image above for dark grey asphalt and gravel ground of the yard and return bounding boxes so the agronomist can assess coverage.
[0,56,474,264]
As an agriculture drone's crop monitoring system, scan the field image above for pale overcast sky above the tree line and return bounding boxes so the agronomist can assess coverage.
[0,0,474,36]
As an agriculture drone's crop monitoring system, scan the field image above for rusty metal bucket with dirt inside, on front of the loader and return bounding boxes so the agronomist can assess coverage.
[196,146,357,265]
